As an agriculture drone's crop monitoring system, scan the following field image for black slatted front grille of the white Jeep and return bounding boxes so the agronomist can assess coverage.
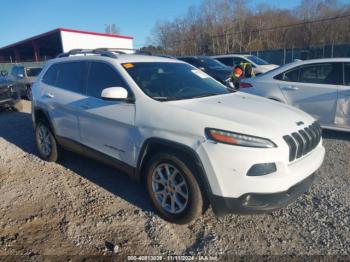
[283,122,322,161]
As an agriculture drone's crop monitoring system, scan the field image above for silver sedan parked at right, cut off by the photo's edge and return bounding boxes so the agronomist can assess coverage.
[240,58,350,131]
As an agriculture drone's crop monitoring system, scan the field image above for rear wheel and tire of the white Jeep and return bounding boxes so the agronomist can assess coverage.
[35,121,59,162]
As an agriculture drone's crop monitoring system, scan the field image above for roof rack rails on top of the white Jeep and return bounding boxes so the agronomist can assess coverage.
[57,48,151,58]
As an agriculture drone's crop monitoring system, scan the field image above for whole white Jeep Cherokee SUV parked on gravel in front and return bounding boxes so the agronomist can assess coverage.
[32,49,325,223]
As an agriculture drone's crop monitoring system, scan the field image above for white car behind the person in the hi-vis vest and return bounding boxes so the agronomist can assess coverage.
[212,54,278,75]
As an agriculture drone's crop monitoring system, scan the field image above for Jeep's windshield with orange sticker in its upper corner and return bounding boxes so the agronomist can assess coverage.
[123,62,232,101]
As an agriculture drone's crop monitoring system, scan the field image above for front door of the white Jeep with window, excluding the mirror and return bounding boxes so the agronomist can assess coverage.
[79,61,135,165]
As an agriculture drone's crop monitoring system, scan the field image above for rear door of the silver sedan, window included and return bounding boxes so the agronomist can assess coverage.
[280,63,342,125]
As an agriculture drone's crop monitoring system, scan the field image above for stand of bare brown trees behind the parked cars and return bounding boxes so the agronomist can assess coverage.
[149,0,350,55]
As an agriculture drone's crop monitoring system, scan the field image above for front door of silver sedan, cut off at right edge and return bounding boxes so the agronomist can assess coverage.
[335,62,350,128]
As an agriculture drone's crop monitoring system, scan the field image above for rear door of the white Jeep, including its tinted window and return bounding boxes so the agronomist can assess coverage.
[40,61,86,142]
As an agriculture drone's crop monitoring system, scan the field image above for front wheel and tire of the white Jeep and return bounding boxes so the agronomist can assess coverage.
[146,152,205,224]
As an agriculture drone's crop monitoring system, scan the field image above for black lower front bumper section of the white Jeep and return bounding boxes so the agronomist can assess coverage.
[211,175,315,216]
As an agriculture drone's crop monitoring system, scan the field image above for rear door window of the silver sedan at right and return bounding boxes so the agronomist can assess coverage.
[299,63,341,85]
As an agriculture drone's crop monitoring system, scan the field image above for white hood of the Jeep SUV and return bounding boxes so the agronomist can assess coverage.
[169,92,314,139]
